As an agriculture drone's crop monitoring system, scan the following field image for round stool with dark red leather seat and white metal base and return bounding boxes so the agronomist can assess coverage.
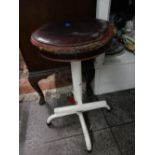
[31,19,113,151]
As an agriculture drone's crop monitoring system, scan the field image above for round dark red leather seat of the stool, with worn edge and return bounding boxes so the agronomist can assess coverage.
[31,19,113,62]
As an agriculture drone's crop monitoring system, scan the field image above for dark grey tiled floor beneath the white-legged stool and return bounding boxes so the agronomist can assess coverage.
[19,89,135,155]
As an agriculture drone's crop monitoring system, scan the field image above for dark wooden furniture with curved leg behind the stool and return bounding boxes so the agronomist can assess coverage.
[19,0,96,104]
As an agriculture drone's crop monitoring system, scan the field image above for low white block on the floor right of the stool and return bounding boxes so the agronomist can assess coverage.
[93,51,135,95]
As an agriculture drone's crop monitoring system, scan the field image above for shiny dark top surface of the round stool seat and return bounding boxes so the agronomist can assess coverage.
[32,20,108,46]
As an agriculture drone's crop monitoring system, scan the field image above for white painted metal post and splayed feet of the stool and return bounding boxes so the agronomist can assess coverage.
[47,61,110,151]
